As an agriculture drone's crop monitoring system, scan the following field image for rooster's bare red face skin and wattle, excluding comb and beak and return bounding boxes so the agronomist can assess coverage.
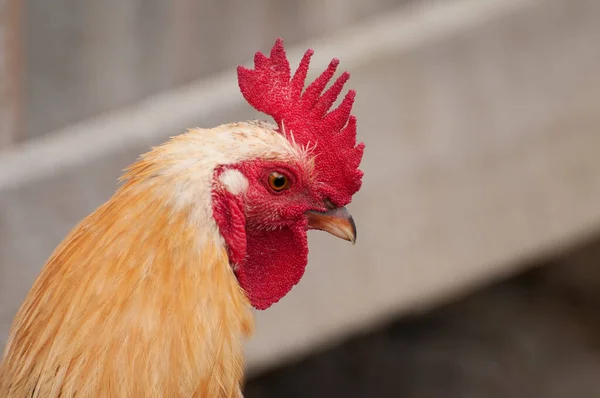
[213,160,327,310]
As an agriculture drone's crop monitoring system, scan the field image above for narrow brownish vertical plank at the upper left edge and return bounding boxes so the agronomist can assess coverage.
[0,0,23,151]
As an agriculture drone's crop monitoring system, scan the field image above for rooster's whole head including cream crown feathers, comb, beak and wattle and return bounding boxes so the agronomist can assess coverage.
[150,39,364,309]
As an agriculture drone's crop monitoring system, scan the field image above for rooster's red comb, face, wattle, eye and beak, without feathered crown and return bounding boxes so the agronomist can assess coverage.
[221,39,364,309]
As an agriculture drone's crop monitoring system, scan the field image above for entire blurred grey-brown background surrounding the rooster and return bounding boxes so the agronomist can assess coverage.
[0,0,600,398]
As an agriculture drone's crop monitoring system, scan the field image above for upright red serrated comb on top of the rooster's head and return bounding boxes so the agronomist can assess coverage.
[237,39,364,206]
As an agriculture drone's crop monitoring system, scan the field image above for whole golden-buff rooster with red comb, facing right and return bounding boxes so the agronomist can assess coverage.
[0,39,364,398]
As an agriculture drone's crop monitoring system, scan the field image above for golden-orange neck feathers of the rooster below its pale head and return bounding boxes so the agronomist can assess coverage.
[0,180,252,397]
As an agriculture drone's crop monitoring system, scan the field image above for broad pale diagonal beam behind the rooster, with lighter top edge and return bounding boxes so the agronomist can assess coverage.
[0,0,600,371]
